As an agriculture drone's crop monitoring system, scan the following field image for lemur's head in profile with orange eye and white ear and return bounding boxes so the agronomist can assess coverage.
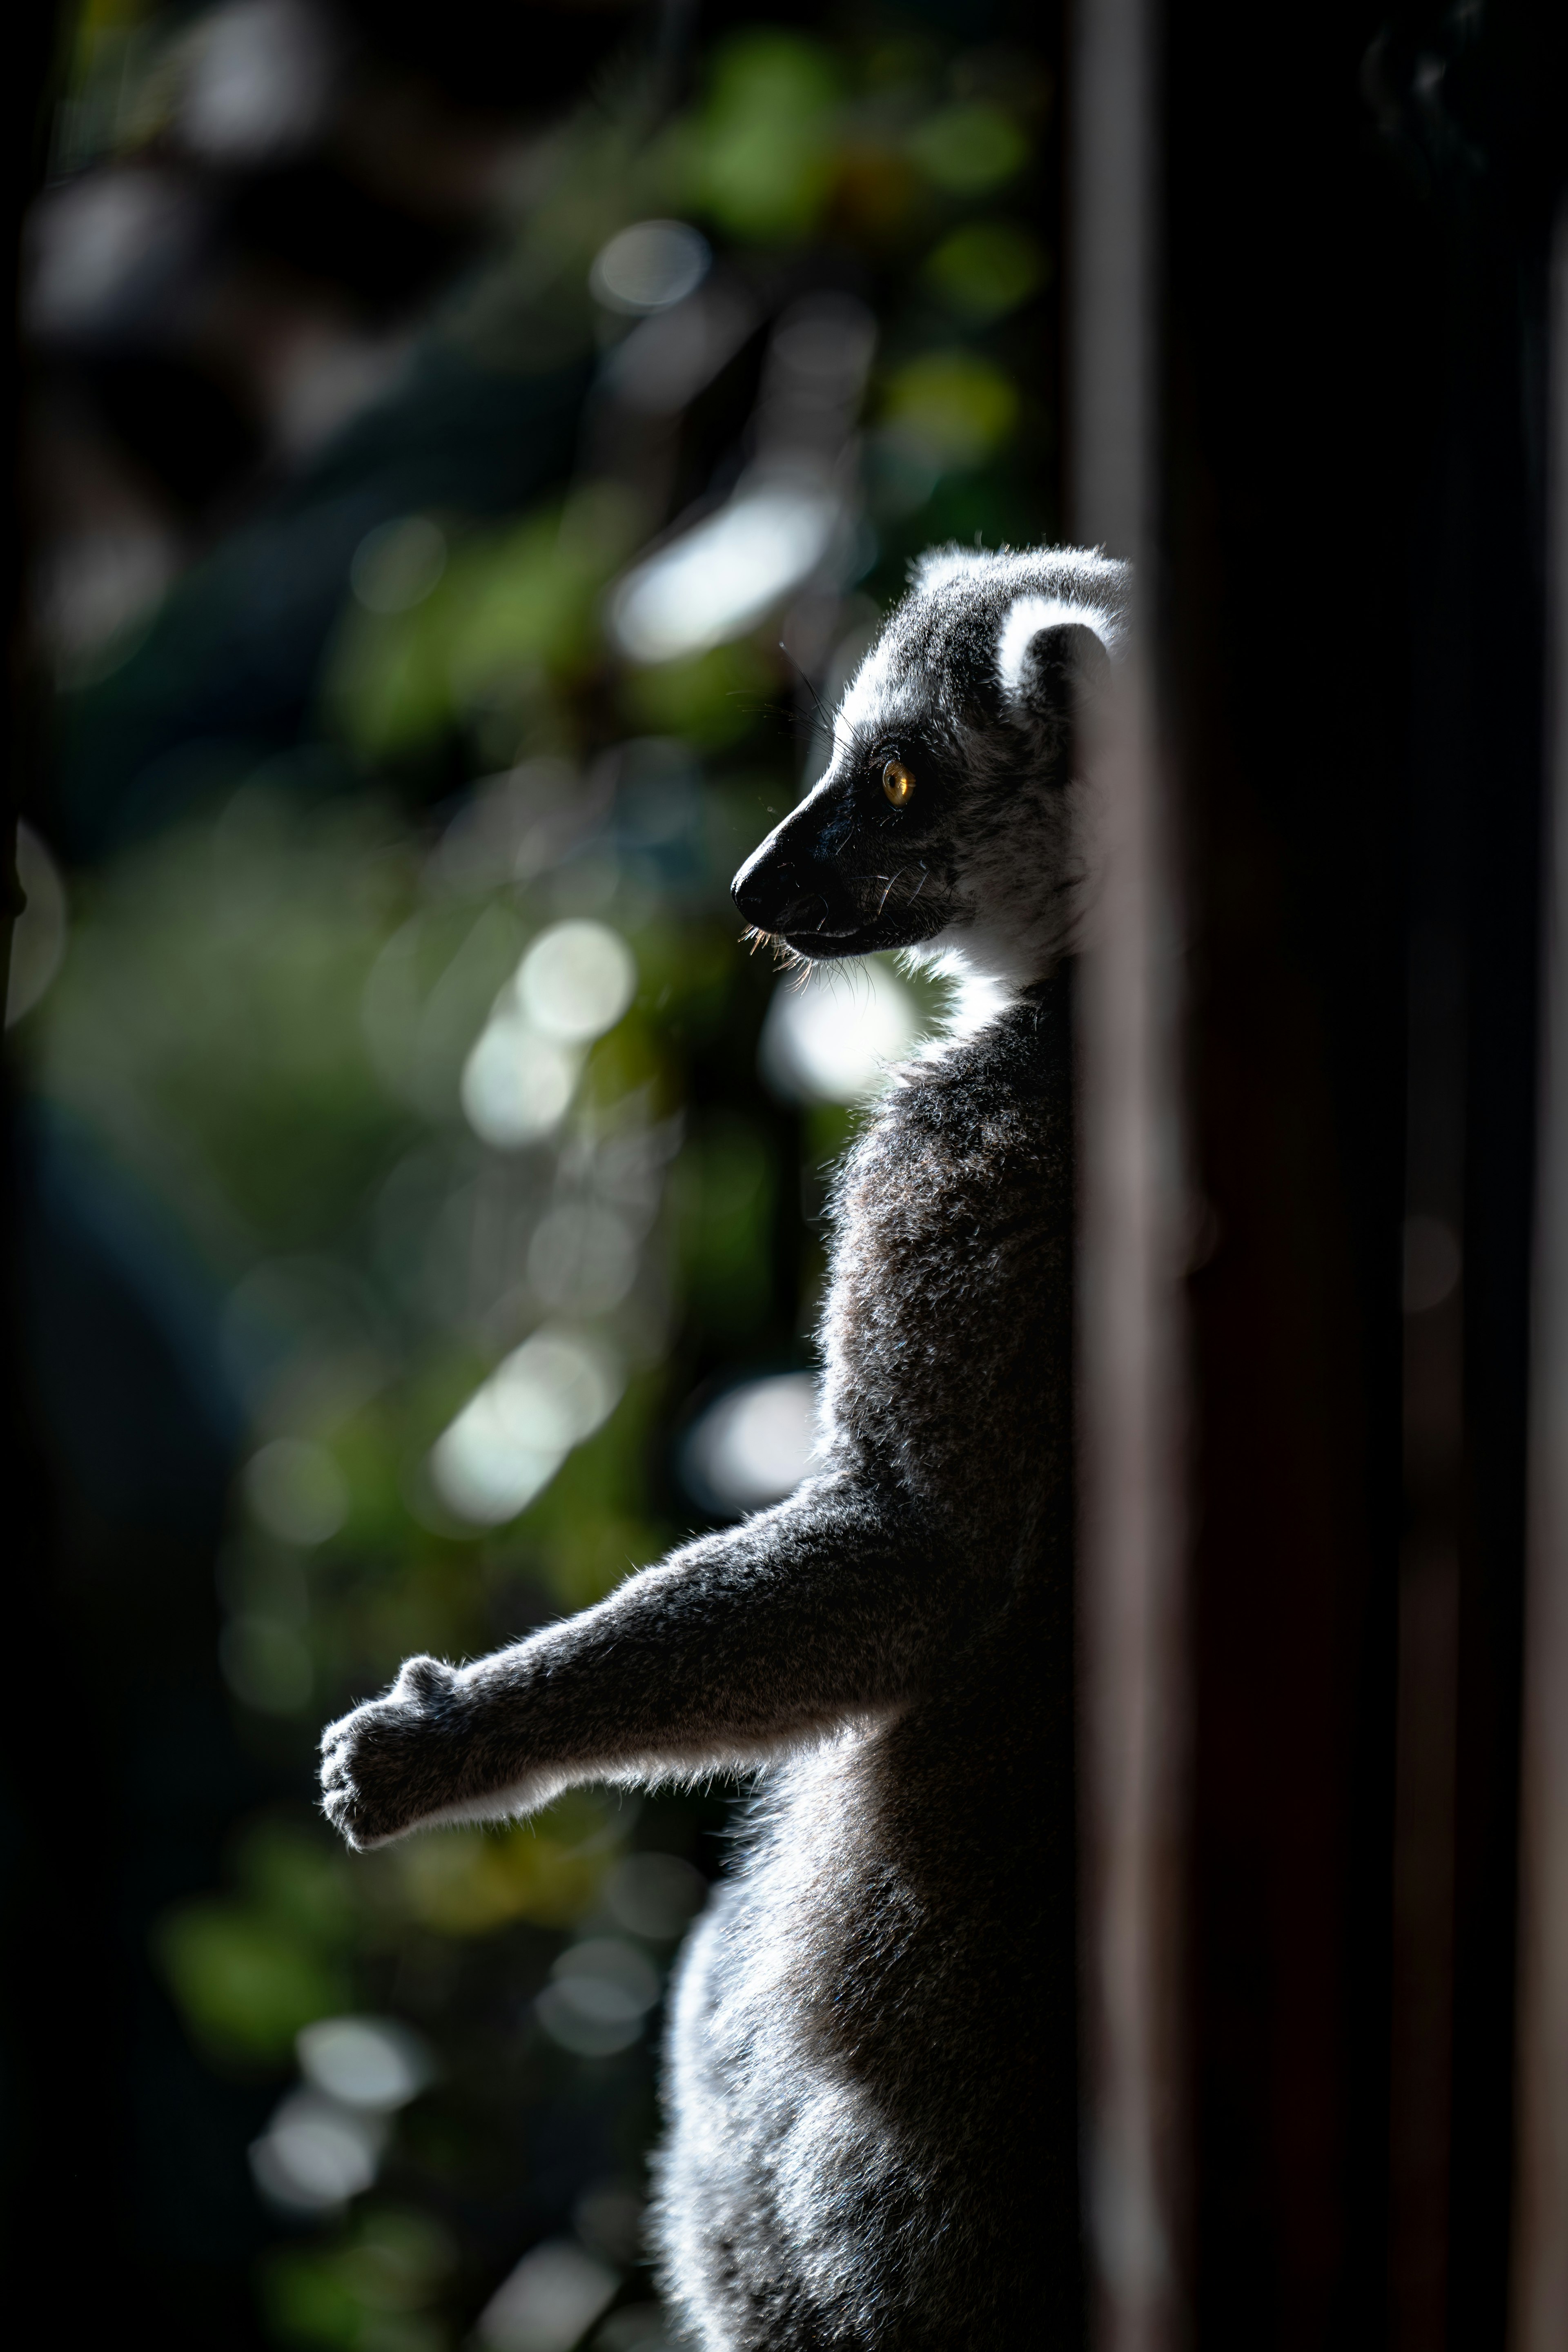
[733,548,1128,988]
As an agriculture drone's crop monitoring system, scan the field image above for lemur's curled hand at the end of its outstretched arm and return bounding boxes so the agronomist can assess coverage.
[322,1658,468,1851]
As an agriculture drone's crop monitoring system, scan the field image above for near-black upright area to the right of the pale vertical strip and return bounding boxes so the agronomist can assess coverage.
[1161,7,1566,2345]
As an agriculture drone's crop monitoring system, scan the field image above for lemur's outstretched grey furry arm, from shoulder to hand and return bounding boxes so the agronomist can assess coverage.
[322,1475,957,1846]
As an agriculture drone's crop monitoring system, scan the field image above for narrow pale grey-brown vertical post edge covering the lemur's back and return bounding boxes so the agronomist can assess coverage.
[1067,0,1185,2352]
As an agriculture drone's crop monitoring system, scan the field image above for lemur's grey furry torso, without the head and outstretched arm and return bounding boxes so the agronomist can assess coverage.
[661,976,1077,2352]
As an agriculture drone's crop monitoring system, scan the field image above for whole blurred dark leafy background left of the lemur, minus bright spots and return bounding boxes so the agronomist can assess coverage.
[5,0,1058,2352]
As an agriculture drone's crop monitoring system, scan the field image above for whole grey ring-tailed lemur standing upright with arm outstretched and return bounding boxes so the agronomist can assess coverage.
[322,550,1126,2352]
